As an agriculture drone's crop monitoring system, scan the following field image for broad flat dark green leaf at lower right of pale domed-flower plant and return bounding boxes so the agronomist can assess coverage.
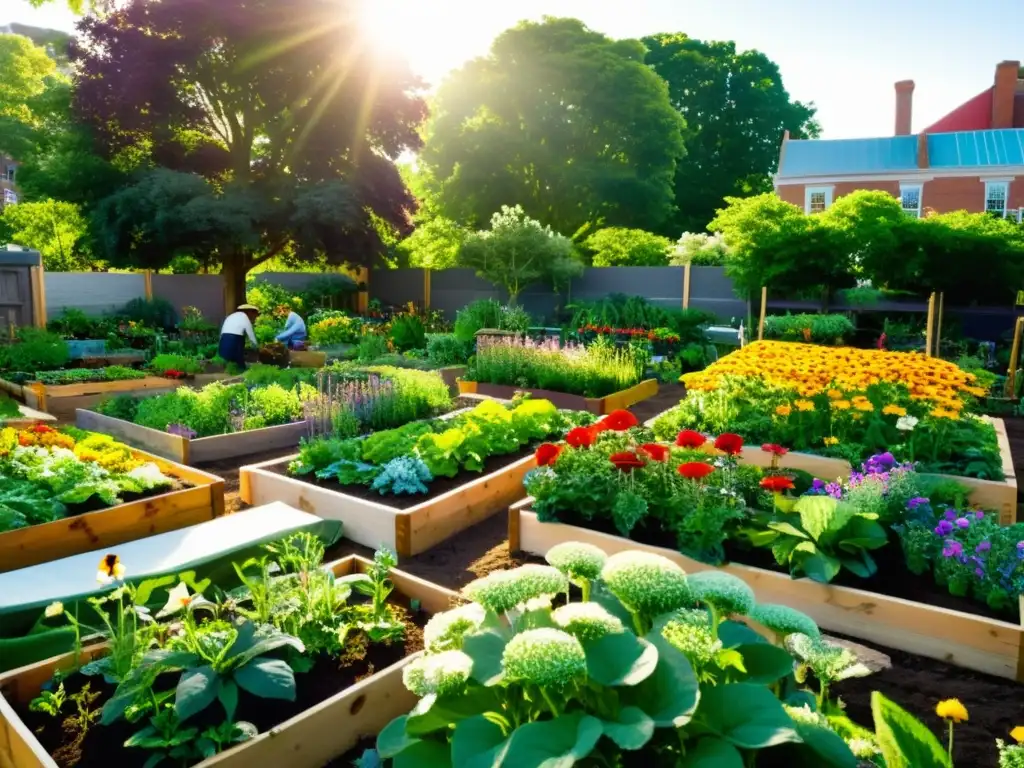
[696,683,800,750]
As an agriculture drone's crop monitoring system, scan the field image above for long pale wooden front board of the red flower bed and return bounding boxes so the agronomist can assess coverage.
[509,499,1024,682]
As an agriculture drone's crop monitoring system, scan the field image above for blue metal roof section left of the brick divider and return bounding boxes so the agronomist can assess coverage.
[778,136,918,176]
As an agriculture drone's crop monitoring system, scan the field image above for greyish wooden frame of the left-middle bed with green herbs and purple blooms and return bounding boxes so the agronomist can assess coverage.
[75,409,309,466]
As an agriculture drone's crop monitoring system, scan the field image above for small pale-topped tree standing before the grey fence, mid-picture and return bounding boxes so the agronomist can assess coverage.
[459,206,583,304]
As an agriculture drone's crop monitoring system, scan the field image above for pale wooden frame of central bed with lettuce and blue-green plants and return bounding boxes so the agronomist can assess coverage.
[239,453,537,558]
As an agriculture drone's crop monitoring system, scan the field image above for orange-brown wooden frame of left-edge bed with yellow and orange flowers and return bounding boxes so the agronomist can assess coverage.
[0,451,224,572]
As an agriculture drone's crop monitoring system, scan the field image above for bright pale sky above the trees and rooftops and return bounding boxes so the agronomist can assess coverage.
[6,0,1024,138]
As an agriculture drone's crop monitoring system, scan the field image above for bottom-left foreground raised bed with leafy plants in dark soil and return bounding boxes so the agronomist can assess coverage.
[0,534,455,768]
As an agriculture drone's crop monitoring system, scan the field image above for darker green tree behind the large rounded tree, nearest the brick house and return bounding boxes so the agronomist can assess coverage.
[643,34,820,237]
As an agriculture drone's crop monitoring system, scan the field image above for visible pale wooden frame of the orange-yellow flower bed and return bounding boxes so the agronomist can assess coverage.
[644,412,1017,525]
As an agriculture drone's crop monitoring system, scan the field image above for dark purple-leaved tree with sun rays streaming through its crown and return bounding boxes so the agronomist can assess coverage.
[74,0,426,306]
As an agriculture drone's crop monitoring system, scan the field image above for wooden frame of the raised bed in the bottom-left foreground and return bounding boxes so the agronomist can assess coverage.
[0,555,460,768]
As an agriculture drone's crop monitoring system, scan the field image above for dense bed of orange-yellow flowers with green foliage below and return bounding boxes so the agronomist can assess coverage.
[654,342,1005,480]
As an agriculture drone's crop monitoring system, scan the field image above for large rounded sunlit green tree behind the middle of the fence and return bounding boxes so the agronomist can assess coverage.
[420,18,684,239]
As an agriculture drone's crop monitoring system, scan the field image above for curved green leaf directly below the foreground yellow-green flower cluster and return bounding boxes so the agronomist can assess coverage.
[620,631,700,728]
